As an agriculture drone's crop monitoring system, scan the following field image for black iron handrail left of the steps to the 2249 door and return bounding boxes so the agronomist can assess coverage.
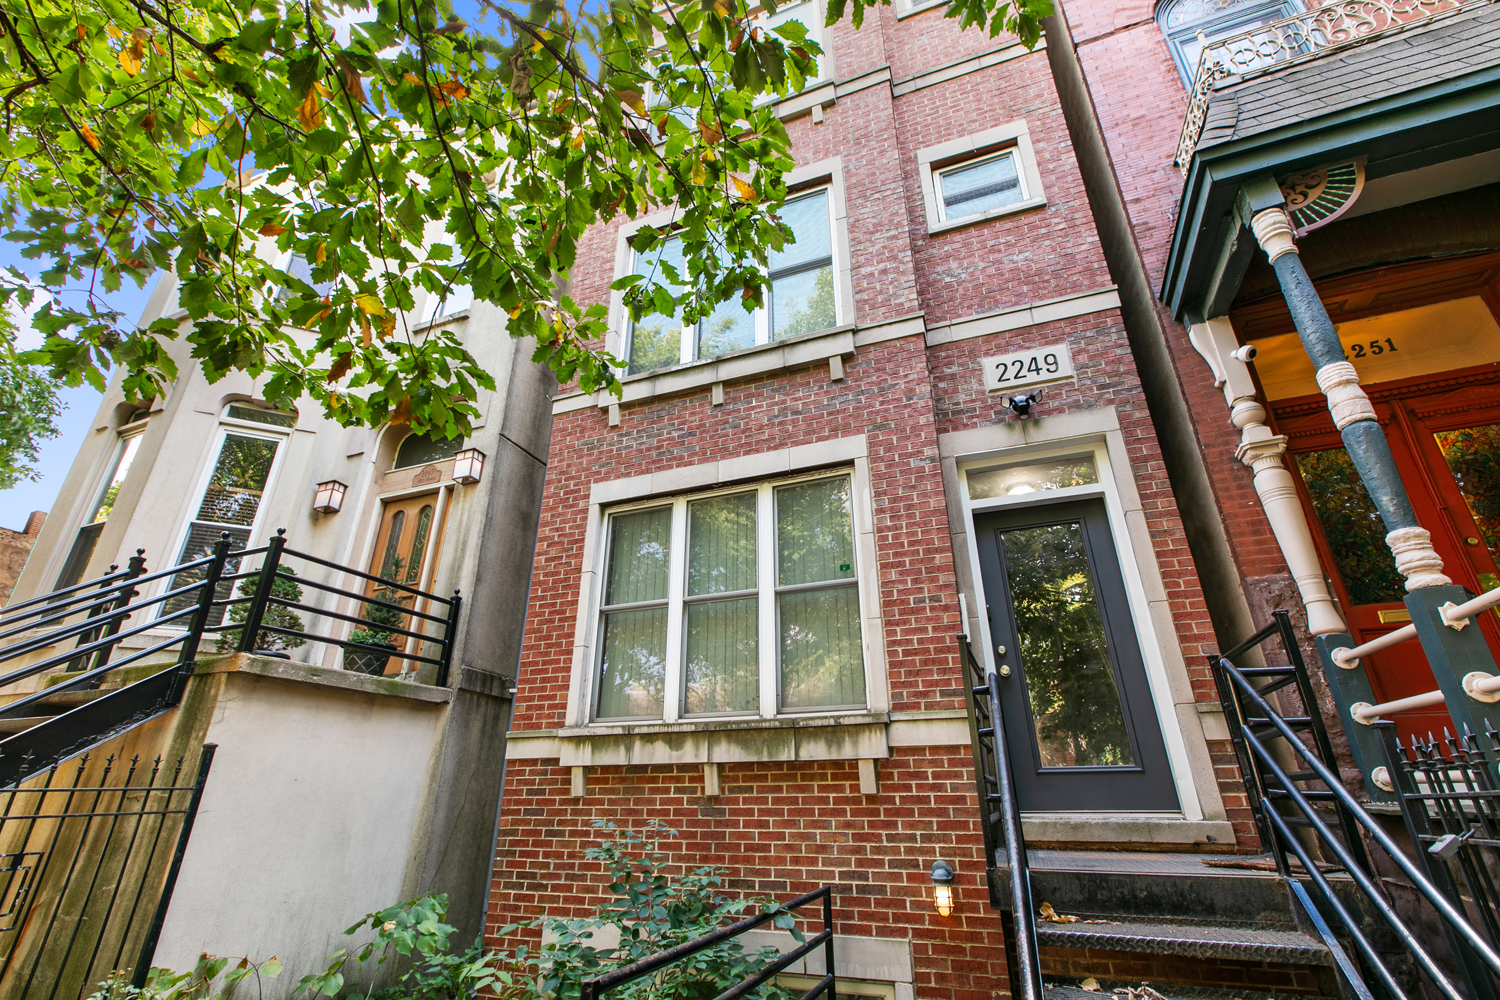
[959,634,1043,1000]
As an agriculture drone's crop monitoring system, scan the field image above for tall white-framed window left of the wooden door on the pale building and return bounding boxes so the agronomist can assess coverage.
[161,402,297,628]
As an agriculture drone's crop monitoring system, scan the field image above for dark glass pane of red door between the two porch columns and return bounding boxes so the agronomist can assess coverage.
[1298,448,1406,604]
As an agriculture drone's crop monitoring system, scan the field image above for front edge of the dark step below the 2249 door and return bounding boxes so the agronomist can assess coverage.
[1037,919,1331,966]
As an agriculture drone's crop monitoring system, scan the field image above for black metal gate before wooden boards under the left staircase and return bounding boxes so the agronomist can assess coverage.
[0,744,216,1000]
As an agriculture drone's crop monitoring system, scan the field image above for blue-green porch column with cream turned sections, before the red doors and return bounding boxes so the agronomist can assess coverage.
[1250,207,1452,591]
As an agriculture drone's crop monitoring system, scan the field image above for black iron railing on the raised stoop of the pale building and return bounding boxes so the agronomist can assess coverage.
[0,531,462,789]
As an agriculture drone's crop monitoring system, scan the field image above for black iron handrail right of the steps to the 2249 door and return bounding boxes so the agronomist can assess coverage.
[1209,612,1500,1000]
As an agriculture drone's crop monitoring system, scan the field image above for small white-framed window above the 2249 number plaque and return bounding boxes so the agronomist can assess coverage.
[917,121,1047,235]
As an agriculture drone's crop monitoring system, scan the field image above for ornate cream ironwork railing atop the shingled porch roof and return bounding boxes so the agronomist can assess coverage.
[1176,0,1490,172]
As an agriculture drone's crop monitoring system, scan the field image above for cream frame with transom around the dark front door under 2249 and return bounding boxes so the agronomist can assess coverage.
[957,435,1205,820]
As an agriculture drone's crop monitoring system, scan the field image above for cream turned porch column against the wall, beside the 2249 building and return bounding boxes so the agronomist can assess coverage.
[1188,316,1347,636]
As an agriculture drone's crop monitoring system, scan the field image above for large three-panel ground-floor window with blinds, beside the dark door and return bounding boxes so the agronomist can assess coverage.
[594,475,867,721]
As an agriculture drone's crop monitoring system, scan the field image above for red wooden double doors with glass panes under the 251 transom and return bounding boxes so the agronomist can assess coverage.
[1281,379,1500,736]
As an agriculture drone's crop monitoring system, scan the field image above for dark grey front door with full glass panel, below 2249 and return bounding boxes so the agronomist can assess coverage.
[974,499,1179,813]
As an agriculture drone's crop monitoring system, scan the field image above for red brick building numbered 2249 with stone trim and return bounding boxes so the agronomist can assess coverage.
[489,0,1356,1000]
